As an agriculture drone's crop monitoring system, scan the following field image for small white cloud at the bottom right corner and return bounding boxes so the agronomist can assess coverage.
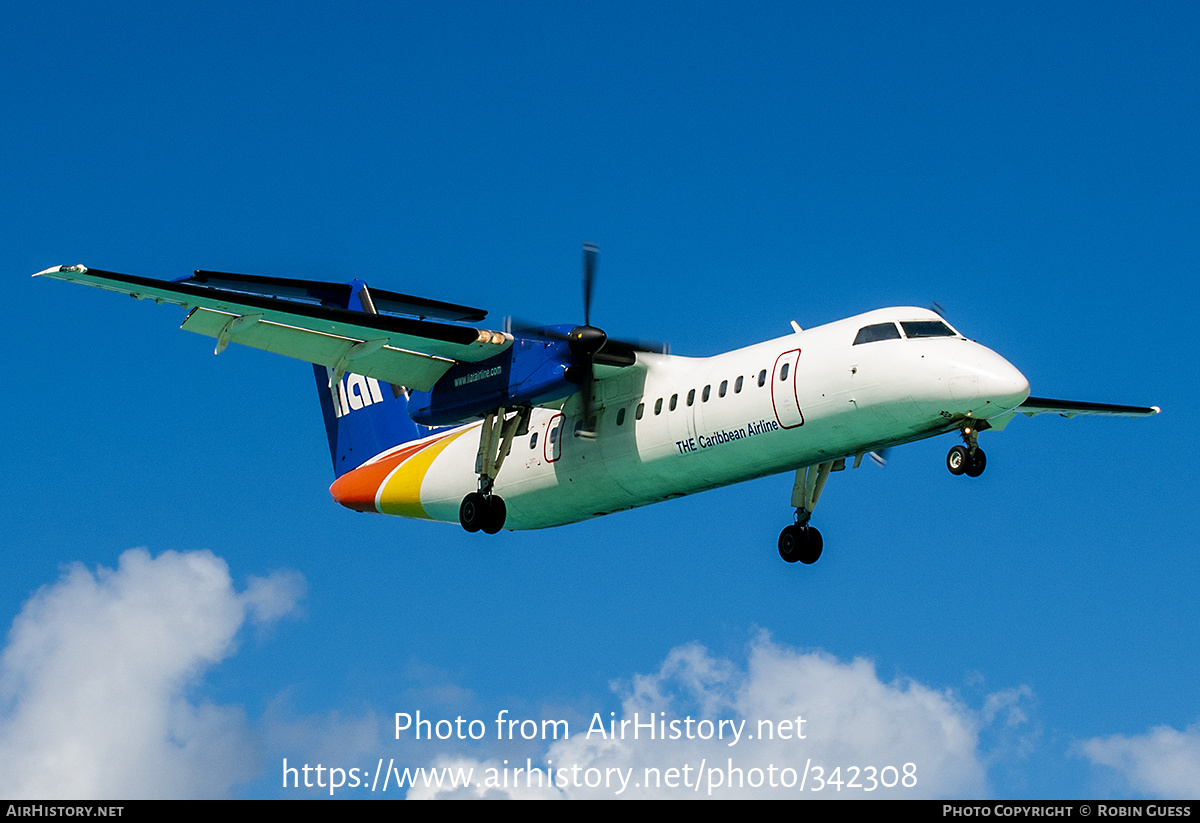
[1079,723,1200,798]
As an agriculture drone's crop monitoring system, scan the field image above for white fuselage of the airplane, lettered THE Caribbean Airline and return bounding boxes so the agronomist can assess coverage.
[335,308,1028,529]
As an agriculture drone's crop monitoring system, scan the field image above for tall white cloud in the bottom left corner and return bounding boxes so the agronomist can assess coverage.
[0,549,304,798]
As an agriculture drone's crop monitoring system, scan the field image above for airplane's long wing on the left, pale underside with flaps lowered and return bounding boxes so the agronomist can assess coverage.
[34,266,512,391]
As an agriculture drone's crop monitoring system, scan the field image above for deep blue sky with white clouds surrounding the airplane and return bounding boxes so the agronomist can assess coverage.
[0,2,1200,798]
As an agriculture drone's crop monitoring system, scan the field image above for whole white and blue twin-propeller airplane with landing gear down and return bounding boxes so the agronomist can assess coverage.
[35,244,1160,564]
